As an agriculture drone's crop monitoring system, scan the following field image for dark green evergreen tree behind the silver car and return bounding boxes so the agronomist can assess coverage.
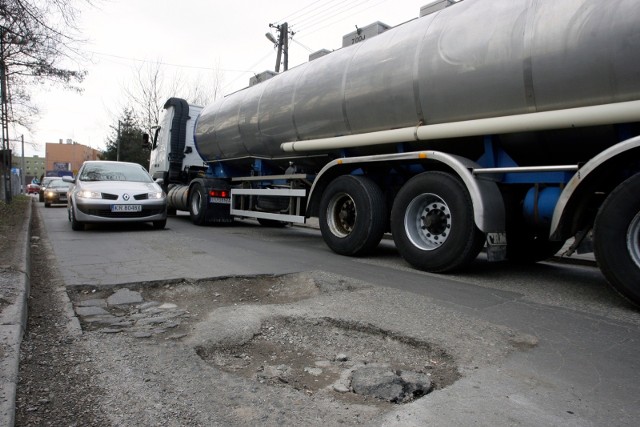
[100,108,150,170]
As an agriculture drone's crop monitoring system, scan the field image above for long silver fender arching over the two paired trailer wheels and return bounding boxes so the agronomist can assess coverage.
[307,151,505,233]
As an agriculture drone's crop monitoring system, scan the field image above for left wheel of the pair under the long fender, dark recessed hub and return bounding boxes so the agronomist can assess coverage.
[319,175,387,256]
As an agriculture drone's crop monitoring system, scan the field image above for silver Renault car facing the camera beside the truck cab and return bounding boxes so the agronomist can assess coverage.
[62,160,167,230]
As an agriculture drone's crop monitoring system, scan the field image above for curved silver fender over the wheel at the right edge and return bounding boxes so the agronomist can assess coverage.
[549,136,640,240]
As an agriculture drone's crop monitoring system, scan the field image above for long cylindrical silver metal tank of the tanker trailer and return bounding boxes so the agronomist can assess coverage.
[195,0,640,167]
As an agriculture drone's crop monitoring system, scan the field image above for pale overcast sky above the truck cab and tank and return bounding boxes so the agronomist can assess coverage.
[10,0,432,157]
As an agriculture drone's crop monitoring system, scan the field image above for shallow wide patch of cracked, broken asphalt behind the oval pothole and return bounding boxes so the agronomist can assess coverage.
[69,272,362,338]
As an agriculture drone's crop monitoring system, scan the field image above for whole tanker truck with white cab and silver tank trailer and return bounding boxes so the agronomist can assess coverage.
[150,0,640,305]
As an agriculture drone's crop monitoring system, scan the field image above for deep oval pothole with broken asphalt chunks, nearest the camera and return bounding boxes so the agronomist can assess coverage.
[196,317,460,406]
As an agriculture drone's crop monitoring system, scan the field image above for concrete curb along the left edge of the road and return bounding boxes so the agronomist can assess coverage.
[0,200,33,427]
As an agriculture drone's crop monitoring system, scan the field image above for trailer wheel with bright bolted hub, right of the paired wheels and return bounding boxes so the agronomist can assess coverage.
[391,172,485,273]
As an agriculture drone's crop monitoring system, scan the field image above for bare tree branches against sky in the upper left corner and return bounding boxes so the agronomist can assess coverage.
[0,0,91,128]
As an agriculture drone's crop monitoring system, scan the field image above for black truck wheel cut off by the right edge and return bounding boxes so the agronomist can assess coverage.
[593,174,640,306]
